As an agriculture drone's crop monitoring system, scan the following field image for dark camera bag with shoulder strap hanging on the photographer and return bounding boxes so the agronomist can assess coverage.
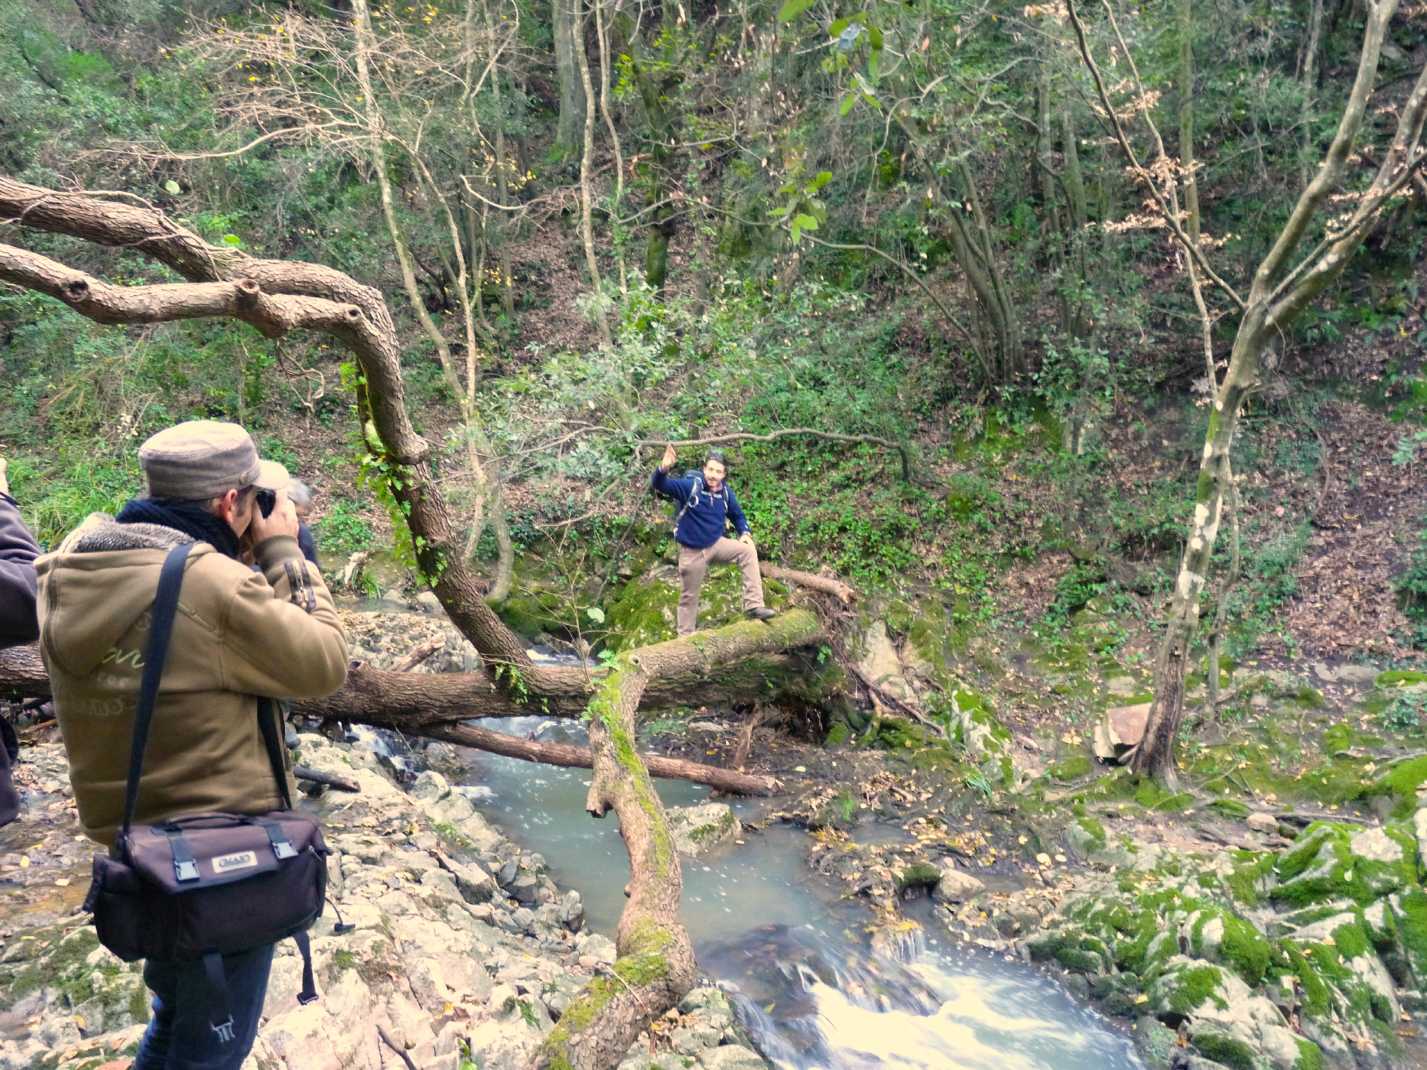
[84,544,339,1036]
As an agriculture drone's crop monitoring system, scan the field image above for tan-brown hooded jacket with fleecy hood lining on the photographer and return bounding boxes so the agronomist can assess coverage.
[36,514,347,846]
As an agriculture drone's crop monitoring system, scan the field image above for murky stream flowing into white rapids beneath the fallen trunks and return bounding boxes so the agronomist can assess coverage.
[450,718,1143,1070]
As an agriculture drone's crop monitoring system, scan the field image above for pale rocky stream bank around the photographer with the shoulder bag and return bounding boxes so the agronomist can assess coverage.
[0,733,765,1070]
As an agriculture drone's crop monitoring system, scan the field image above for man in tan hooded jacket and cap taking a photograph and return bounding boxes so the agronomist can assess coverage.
[37,421,347,1070]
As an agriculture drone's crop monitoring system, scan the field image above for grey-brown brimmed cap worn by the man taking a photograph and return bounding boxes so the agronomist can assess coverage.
[138,419,288,501]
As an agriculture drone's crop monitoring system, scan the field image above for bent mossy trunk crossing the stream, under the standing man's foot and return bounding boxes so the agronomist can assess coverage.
[532,609,822,1070]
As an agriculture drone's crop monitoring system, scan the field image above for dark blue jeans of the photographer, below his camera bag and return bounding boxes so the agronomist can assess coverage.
[133,944,273,1070]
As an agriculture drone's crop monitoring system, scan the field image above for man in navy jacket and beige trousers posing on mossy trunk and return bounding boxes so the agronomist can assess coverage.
[649,445,775,636]
